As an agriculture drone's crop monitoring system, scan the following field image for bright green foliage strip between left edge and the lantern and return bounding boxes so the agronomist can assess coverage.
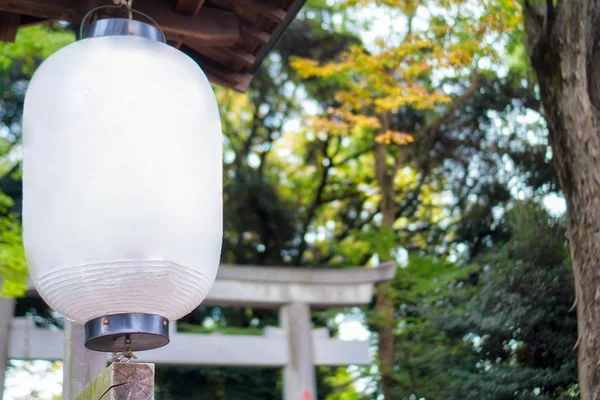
[0,25,75,297]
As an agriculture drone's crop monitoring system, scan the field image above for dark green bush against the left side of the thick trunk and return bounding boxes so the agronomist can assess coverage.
[429,203,577,399]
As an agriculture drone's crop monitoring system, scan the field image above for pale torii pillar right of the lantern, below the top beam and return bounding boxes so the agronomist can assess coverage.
[280,303,317,400]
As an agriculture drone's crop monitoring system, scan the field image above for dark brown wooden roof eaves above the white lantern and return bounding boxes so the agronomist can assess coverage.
[0,0,305,91]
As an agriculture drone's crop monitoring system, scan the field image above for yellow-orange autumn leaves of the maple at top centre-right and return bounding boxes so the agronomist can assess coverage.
[292,0,522,145]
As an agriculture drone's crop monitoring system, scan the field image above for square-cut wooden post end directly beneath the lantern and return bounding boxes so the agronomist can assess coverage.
[76,363,154,400]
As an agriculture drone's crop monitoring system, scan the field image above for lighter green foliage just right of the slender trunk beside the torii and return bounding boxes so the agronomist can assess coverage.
[372,255,477,400]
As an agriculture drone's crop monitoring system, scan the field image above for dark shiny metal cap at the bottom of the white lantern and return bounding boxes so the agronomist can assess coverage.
[85,313,169,352]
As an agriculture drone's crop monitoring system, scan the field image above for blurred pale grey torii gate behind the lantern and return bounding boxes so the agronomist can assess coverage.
[0,264,396,400]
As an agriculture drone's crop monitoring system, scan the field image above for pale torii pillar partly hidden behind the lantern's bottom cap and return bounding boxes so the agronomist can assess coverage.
[63,321,107,400]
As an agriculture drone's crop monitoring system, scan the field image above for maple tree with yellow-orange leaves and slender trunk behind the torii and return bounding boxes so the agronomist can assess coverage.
[292,0,521,398]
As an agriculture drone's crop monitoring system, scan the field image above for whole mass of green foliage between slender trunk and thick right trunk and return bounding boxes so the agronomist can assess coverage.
[360,203,578,400]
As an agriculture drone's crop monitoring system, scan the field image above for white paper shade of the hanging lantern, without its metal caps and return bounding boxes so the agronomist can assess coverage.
[23,36,222,323]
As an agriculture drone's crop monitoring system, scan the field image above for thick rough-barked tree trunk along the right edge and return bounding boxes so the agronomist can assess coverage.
[524,0,600,400]
